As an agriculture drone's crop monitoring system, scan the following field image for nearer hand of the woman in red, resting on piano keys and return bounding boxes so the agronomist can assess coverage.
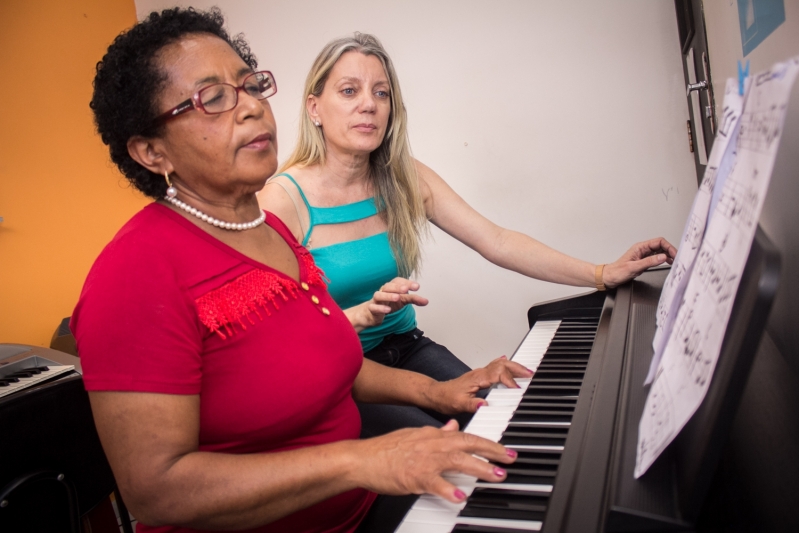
[351,420,517,503]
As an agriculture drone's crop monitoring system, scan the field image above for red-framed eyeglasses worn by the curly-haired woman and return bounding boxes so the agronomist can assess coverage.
[155,70,277,124]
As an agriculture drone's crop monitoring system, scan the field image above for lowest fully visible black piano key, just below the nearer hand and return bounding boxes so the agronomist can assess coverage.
[458,488,549,521]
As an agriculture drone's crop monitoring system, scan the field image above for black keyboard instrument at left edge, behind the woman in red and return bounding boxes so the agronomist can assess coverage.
[0,344,119,533]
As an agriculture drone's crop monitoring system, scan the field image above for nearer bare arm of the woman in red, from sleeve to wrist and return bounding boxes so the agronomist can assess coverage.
[89,392,359,529]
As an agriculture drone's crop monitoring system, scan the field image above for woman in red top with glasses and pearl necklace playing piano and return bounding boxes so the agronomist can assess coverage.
[72,9,530,532]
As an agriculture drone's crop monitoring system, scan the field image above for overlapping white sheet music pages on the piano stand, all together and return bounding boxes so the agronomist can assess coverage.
[635,58,799,478]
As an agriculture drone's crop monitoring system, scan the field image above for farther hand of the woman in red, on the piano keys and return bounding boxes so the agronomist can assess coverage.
[425,355,533,415]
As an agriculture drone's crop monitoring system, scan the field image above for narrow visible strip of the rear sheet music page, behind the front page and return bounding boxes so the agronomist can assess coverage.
[644,79,743,385]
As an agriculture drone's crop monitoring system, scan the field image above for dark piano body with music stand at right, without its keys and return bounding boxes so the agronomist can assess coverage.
[528,225,799,533]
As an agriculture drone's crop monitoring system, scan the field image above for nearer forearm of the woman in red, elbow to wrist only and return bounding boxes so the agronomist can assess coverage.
[134,441,358,530]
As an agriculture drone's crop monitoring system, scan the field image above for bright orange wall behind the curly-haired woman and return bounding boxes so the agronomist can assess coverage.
[0,0,147,346]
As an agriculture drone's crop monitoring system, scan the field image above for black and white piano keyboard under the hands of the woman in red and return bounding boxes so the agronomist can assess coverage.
[397,317,599,533]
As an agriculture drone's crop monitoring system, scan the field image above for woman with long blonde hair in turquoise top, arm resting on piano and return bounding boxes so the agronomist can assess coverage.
[259,33,676,435]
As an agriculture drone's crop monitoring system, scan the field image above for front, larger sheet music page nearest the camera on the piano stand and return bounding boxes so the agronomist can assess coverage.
[635,57,799,478]
